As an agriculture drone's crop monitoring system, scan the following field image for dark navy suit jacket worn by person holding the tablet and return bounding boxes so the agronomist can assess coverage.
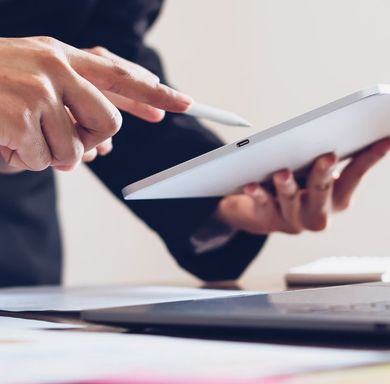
[0,0,265,286]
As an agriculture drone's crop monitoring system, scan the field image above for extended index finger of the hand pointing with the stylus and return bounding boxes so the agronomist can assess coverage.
[65,45,192,112]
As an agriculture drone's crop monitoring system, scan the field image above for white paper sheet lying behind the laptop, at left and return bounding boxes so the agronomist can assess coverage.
[0,286,250,312]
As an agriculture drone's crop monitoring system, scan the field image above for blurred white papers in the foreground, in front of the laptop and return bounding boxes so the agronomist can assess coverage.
[0,329,390,384]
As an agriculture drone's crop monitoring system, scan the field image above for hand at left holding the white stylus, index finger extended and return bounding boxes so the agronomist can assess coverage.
[0,37,191,172]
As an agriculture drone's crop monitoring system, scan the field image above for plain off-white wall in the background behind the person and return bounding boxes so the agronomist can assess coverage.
[59,0,390,284]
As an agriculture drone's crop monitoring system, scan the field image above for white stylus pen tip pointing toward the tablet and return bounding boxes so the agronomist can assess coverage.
[184,102,252,127]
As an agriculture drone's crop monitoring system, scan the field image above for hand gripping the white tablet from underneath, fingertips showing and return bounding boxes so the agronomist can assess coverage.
[216,138,390,235]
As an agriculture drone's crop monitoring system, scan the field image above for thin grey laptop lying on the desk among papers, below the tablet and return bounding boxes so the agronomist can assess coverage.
[82,282,390,335]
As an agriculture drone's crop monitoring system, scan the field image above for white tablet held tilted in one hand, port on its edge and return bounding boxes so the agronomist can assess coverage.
[122,84,390,200]
